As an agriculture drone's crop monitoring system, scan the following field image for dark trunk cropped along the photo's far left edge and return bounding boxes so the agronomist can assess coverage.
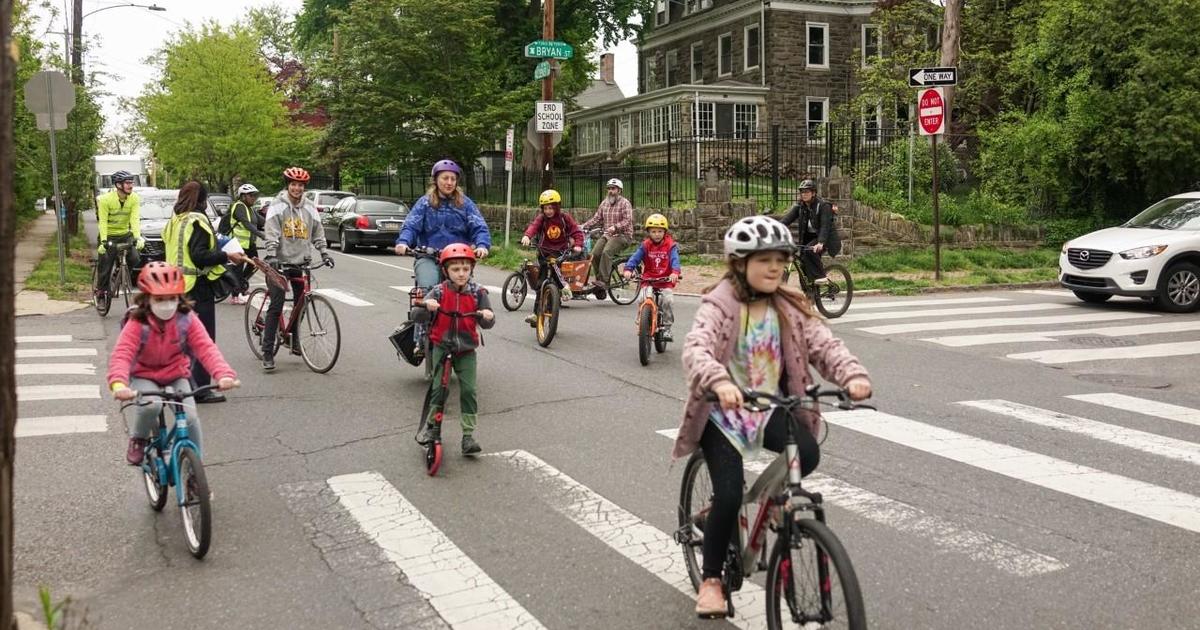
[0,0,17,629]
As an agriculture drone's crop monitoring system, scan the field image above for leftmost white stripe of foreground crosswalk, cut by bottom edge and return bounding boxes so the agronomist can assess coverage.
[328,473,545,630]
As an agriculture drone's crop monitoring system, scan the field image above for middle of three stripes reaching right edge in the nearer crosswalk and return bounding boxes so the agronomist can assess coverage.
[959,400,1200,464]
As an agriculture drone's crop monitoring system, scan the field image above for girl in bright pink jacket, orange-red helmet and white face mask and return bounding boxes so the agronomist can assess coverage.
[108,262,238,466]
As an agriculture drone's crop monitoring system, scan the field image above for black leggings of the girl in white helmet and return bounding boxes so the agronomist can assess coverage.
[700,409,821,580]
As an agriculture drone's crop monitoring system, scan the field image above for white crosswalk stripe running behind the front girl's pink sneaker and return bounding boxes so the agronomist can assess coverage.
[490,450,767,629]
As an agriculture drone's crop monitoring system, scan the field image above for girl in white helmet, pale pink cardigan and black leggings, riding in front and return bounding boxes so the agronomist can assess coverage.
[673,216,871,618]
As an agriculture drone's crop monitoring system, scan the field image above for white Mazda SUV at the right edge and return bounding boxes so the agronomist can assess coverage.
[1058,192,1200,313]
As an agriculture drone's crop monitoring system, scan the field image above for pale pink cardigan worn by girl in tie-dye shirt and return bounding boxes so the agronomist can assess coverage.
[671,280,869,457]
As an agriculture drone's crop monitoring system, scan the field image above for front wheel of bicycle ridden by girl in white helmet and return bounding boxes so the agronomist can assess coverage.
[766,518,866,630]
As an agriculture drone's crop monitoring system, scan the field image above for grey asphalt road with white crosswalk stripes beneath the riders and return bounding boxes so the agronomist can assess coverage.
[9,238,1200,629]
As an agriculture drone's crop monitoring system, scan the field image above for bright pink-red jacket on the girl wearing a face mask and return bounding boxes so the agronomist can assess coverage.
[108,313,238,388]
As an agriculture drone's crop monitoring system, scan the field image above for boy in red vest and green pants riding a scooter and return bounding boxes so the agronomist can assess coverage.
[418,242,496,455]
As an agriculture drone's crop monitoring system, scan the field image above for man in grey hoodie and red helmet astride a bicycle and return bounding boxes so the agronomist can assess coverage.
[263,167,334,371]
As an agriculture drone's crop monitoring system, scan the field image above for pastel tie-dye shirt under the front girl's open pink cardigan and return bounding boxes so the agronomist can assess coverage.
[708,306,784,457]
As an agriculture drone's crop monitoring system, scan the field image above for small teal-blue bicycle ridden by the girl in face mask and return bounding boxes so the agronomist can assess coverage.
[121,384,229,559]
